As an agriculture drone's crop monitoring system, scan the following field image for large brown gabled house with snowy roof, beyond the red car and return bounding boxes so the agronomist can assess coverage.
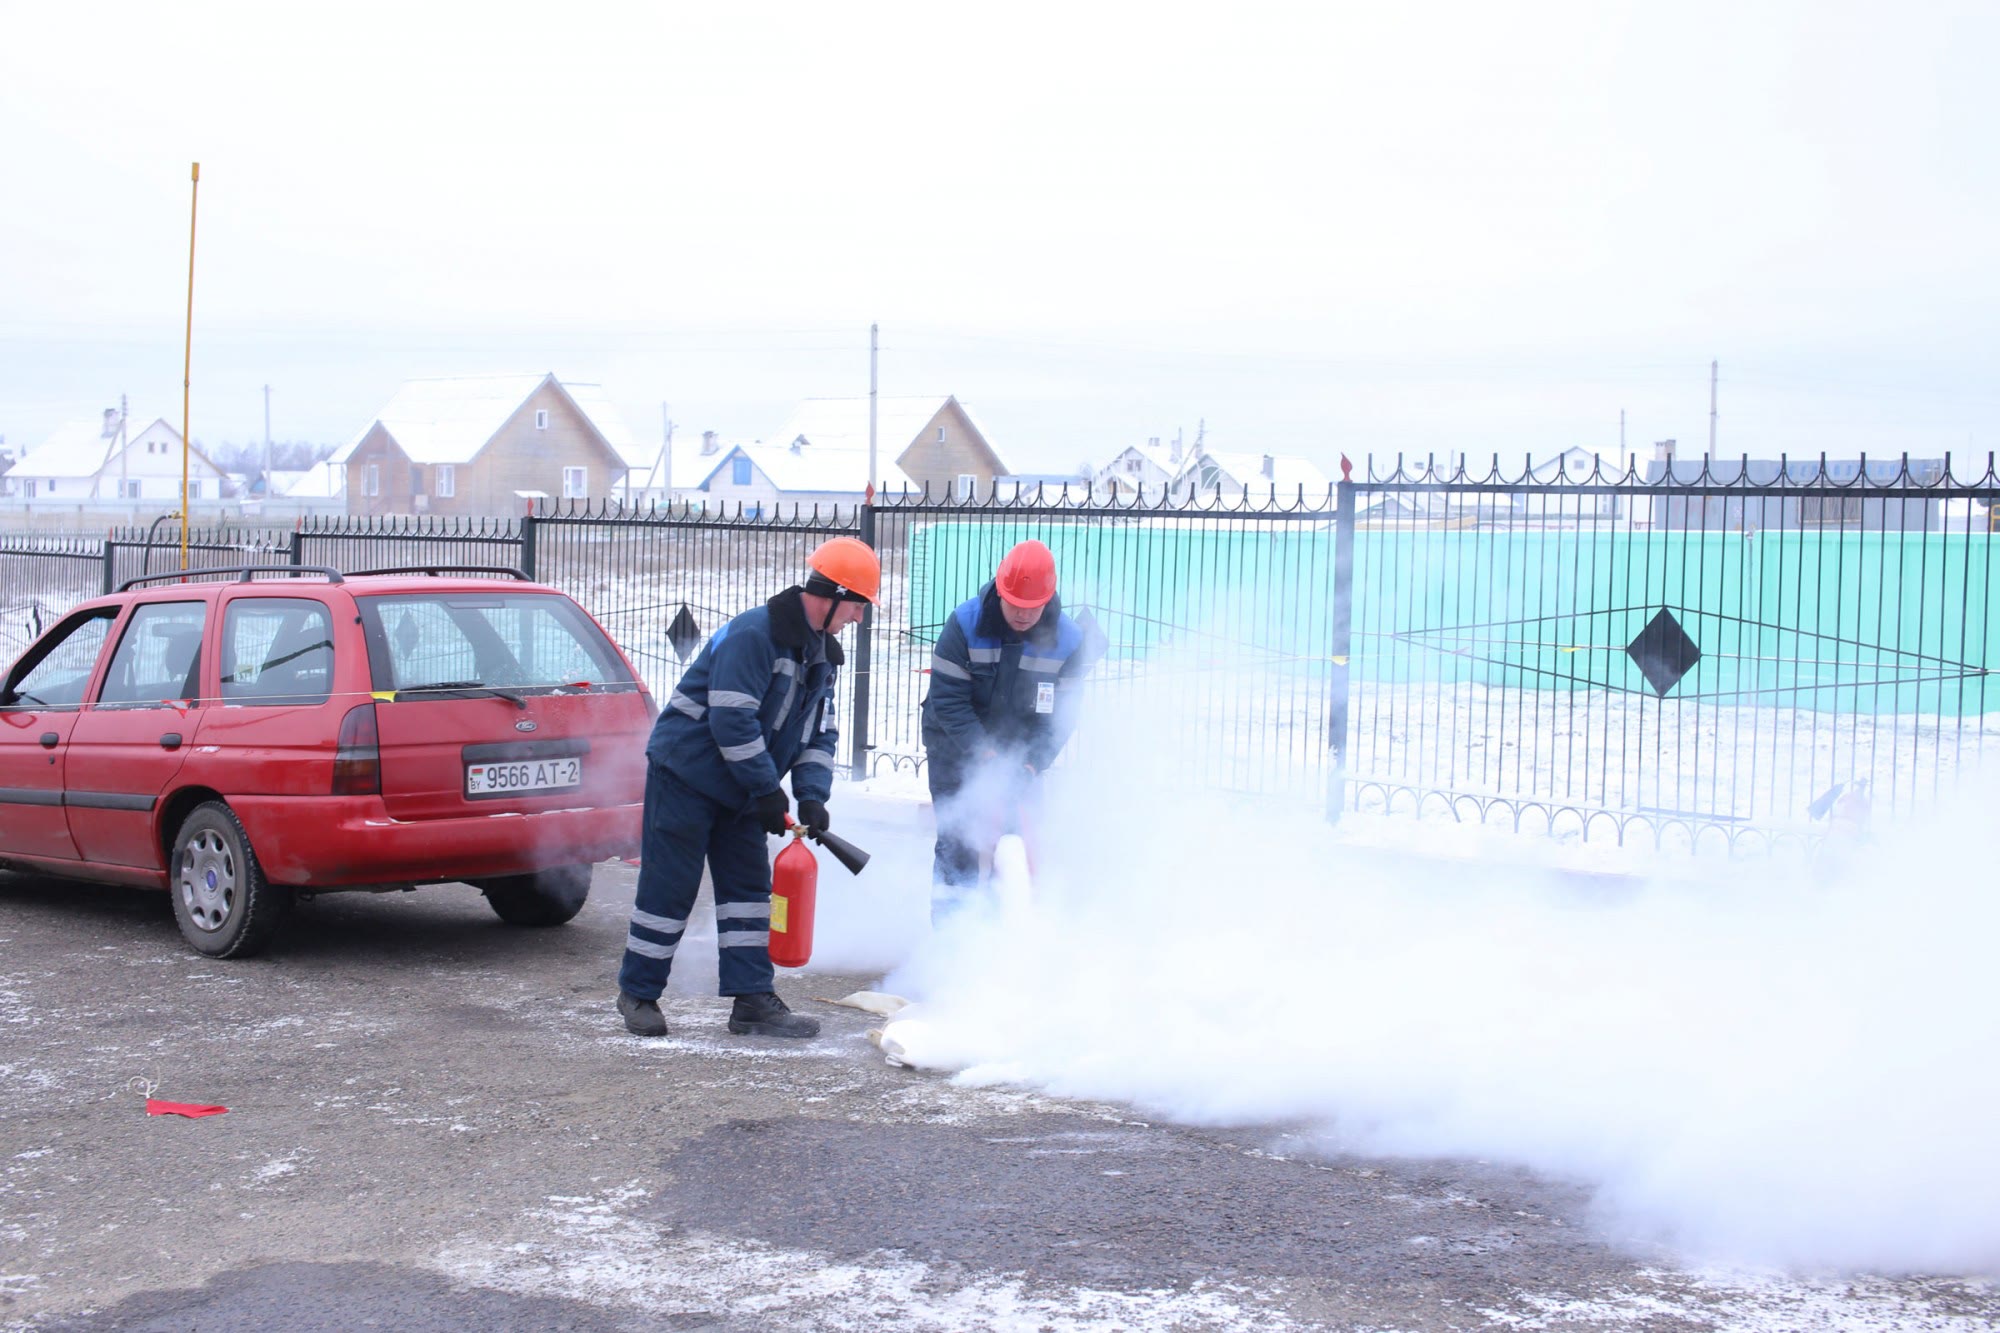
[330,374,658,516]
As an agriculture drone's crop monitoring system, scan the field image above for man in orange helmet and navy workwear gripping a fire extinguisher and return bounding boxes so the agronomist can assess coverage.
[618,536,882,1037]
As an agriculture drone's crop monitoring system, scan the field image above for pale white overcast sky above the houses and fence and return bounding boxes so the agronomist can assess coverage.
[0,0,2000,470]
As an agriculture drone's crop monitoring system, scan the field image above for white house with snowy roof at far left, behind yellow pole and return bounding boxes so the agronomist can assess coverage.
[6,408,226,506]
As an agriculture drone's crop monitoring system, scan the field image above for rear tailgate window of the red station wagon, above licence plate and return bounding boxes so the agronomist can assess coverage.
[356,592,634,691]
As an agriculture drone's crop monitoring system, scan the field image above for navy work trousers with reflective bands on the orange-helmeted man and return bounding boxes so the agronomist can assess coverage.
[618,765,772,1001]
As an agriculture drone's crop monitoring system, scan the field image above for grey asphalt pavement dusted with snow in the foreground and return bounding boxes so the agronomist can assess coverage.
[0,865,2000,1331]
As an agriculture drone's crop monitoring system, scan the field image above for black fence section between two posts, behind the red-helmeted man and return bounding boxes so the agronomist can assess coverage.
[862,494,1334,795]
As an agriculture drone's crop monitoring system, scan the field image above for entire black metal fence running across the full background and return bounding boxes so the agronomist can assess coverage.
[0,460,2000,845]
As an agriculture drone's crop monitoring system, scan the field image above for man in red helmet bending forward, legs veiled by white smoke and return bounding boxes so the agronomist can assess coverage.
[924,540,1104,923]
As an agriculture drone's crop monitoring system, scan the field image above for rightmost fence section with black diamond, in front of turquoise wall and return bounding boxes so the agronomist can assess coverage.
[1330,458,2000,847]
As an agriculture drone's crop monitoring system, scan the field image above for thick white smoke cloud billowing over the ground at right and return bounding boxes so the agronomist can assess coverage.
[864,720,2000,1271]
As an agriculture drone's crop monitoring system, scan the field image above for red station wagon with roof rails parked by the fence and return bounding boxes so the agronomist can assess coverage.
[0,566,656,957]
